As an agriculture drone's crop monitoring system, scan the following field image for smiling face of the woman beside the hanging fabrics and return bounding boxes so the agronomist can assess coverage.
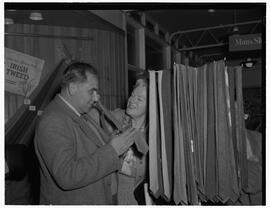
[126,86,147,119]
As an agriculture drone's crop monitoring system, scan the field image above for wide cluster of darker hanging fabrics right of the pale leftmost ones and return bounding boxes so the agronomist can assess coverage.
[173,60,253,205]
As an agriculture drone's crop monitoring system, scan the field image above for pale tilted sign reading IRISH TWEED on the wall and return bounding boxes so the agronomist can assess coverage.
[5,48,44,97]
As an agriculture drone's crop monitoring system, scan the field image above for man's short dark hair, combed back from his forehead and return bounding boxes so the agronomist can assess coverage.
[61,62,98,88]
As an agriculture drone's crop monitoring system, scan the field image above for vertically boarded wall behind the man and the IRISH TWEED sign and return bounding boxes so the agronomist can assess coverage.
[5,24,127,125]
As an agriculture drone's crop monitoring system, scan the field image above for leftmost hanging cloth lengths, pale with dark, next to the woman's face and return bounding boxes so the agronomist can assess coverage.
[149,70,173,202]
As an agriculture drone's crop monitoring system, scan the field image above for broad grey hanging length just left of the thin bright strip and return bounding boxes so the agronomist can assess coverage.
[214,62,238,203]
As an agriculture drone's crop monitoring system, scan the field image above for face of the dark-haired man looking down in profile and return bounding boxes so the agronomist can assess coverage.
[73,72,98,113]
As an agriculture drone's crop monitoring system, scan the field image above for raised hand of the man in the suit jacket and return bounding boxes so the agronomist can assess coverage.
[110,128,136,156]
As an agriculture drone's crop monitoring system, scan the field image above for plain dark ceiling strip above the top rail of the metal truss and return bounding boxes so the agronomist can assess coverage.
[145,8,263,33]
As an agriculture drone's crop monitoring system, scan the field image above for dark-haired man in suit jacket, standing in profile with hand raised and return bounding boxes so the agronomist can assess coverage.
[35,63,134,205]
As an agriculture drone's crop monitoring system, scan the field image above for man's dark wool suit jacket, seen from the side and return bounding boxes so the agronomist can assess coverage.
[35,96,121,205]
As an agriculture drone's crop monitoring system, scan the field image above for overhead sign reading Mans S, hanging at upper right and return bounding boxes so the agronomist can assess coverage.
[229,33,262,51]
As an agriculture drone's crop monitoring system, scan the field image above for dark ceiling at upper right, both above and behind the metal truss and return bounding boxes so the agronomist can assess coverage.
[144,7,265,59]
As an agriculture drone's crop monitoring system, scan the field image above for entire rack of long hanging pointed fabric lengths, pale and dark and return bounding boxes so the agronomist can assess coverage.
[149,60,248,205]
